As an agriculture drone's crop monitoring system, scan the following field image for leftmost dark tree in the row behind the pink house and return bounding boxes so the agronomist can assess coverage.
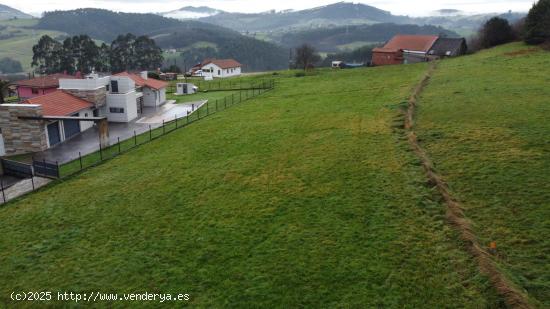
[31,35,63,74]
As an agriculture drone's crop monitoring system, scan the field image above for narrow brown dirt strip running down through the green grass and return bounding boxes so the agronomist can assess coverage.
[404,62,532,308]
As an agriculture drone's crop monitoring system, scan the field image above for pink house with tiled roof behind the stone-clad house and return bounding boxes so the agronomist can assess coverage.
[14,74,77,100]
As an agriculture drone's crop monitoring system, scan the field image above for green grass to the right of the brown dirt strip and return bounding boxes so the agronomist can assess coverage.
[417,43,550,308]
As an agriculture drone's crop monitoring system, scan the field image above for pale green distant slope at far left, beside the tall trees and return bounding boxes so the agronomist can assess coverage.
[0,19,63,71]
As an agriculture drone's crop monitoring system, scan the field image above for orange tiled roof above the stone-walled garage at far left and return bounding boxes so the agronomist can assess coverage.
[23,90,94,116]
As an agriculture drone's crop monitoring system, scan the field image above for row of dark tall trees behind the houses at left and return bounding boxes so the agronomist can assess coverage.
[32,33,164,74]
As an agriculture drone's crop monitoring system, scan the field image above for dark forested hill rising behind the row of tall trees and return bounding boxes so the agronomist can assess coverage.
[35,9,288,71]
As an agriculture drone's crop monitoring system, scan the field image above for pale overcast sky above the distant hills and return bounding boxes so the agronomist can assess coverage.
[0,0,534,16]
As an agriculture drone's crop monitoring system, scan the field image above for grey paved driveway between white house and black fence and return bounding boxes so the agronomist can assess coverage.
[34,101,206,164]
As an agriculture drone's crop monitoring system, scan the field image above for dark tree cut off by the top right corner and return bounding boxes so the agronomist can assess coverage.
[525,0,550,44]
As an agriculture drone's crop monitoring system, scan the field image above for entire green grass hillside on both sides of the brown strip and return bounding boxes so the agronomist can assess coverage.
[0,44,550,308]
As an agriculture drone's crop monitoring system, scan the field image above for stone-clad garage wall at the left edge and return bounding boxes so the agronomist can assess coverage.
[0,104,48,155]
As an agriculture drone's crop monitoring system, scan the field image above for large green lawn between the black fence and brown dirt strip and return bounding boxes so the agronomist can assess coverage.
[0,64,500,308]
